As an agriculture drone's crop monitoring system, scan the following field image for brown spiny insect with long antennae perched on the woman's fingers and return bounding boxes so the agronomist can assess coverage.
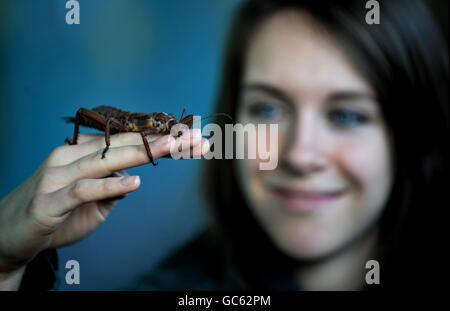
[63,106,232,166]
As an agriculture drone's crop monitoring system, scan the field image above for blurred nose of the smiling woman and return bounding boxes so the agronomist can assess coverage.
[281,111,326,174]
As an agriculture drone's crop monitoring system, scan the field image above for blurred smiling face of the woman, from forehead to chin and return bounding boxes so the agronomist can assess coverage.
[235,11,393,259]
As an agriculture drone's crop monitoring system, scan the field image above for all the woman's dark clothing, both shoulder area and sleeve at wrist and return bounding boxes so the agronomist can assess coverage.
[20,231,298,291]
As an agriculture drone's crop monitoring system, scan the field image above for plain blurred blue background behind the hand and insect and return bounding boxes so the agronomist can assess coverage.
[0,0,238,290]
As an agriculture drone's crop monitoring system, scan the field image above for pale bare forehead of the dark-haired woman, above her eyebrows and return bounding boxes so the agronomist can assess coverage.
[243,11,373,100]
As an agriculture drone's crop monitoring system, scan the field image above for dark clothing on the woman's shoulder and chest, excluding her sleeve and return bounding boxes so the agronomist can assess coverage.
[136,231,298,290]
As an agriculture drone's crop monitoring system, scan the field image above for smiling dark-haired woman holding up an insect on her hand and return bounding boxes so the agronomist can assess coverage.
[0,0,448,290]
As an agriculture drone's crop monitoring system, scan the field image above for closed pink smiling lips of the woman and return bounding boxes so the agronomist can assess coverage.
[271,187,345,212]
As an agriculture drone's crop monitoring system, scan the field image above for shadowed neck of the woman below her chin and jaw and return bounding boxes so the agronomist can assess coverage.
[295,228,378,290]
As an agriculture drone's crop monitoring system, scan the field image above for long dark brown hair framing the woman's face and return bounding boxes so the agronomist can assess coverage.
[204,0,450,288]
